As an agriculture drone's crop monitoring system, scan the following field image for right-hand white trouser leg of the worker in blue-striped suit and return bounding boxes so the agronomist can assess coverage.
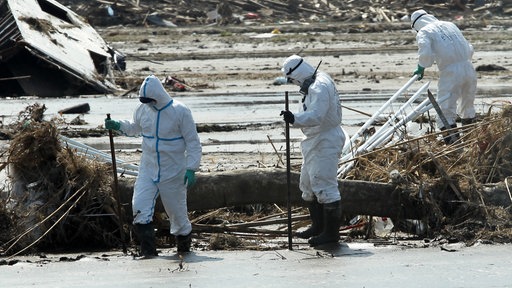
[158,174,192,236]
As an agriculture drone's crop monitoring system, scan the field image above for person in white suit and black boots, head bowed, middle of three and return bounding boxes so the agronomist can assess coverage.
[281,55,345,246]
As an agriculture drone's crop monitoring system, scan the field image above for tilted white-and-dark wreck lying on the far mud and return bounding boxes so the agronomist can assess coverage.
[0,0,126,97]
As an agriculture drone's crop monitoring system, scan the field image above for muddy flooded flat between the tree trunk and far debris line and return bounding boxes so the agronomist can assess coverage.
[0,20,512,160]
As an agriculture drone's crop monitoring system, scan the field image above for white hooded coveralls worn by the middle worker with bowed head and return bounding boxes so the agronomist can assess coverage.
[282,55,345,204]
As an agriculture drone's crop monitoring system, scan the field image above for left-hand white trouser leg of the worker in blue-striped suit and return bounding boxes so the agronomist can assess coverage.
[132,176,158,224]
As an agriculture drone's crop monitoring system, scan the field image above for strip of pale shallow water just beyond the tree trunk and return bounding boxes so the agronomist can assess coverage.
[0,85,512,153]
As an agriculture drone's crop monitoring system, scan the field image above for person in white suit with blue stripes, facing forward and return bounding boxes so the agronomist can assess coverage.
[105,75,201,256]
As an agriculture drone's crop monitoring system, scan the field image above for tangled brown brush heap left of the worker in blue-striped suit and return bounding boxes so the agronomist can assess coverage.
[0,104,119,254]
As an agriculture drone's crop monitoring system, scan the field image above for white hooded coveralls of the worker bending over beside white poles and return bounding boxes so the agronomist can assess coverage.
[411,10,477,128]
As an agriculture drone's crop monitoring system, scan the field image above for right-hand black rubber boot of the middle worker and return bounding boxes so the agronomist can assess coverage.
[308,201,341,246]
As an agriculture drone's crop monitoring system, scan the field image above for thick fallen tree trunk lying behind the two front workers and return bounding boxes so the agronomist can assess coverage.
[120,169,423,219]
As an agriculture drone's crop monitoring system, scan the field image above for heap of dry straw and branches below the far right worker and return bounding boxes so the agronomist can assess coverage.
[346,104,512,243]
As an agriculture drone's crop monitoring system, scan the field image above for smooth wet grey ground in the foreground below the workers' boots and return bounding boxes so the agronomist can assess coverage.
[0,242,512,288]
